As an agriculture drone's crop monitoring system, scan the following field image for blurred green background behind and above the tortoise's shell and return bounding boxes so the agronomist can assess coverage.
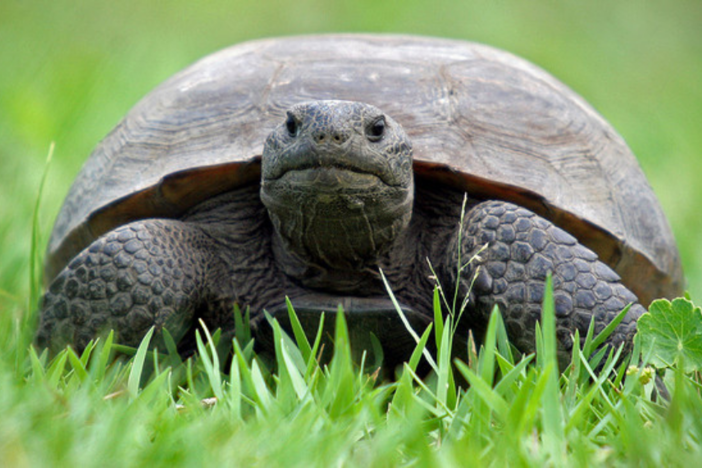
[0,0,702,313]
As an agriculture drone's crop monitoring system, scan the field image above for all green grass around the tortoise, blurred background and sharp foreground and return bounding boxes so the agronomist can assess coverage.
[0,0,702,466]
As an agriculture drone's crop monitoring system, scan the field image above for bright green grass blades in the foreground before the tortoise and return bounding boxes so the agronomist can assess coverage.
[0,278,702,466]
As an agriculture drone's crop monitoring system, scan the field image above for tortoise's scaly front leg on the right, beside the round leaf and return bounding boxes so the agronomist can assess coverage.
[444,201,645,367]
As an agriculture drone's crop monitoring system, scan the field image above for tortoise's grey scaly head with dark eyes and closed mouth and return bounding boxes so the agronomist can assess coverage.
[261,101,414,282]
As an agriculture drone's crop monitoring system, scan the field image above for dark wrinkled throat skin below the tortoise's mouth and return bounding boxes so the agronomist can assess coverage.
[268,182,414,295]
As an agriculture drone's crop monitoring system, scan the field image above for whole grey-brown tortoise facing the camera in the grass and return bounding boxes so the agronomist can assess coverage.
[37,35,683,365]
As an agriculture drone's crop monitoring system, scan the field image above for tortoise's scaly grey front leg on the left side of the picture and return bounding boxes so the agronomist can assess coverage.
[36,220,228,354]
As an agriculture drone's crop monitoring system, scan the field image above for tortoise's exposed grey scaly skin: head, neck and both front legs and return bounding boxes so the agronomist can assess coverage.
[37,101,643,364]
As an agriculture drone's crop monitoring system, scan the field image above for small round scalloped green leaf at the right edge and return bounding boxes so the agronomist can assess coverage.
[636,298,702,372]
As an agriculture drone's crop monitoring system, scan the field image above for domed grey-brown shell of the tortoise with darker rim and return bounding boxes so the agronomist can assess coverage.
[46,35,682,304]
